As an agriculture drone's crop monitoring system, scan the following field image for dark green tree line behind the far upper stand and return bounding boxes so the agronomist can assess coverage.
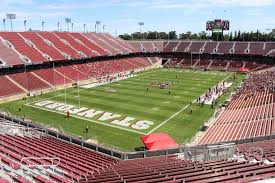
[119,31,275,41]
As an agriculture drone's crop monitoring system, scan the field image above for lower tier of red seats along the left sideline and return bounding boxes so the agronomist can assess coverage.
[0,57,156,98]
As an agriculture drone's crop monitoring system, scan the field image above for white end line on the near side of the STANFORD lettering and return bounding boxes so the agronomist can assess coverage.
[25,104,146,135]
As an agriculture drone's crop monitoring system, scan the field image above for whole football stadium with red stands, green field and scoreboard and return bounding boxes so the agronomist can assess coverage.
[0,0,275,183]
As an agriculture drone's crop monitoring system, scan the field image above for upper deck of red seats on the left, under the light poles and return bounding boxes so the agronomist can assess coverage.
[0,32,137,66]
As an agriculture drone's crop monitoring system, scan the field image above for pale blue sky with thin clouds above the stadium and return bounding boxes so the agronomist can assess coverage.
[0,0,275,35]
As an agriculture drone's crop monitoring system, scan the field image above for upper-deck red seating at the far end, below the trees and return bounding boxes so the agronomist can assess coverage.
[128,40,275,56]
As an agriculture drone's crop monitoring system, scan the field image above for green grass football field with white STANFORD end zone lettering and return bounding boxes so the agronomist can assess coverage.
[0,69,246,151]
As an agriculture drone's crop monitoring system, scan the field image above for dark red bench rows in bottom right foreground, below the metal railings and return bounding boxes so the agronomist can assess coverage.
[82,153,275,183]
